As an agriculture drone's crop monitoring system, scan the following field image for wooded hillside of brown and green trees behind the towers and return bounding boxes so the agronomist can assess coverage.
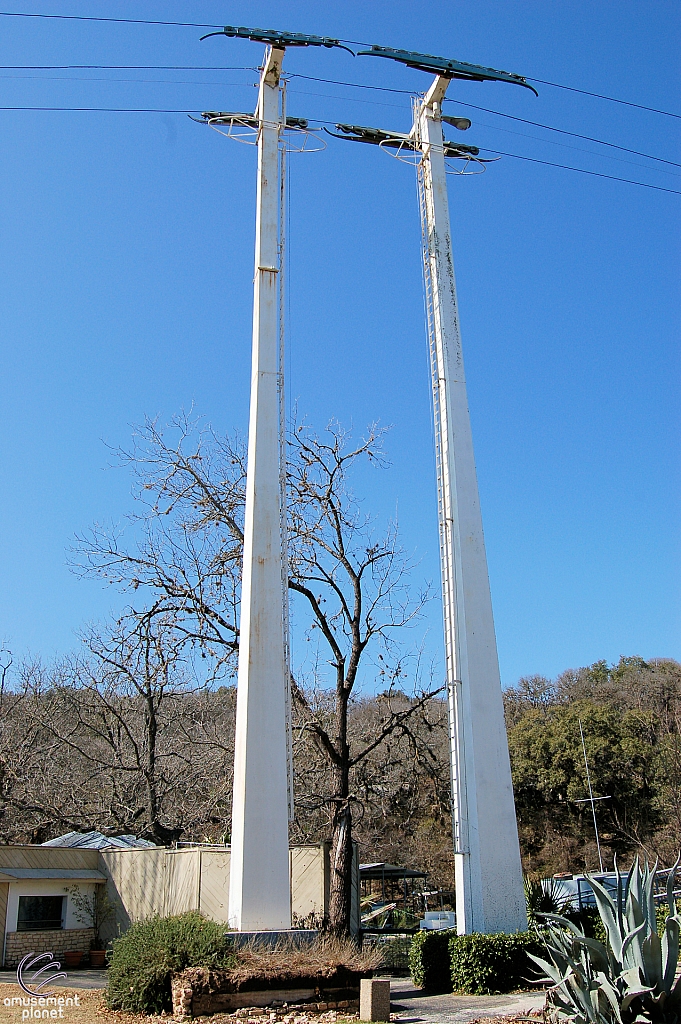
[0,650,681,887]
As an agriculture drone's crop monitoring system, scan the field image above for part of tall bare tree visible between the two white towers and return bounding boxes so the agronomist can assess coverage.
[289,425,439,933]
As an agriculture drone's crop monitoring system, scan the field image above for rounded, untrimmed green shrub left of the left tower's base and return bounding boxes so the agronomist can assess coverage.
[107,910,236,1014]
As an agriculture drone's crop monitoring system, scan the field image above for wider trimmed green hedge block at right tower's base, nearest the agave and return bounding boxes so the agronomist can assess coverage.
[449,932,541,995]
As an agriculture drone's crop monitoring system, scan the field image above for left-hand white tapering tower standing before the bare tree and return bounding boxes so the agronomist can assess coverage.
[228,46,291,932]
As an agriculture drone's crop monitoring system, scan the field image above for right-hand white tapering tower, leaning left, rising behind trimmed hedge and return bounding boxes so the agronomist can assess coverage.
[412,76,527,934]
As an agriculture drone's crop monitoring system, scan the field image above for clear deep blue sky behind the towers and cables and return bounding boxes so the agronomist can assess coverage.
[0,0,681,685]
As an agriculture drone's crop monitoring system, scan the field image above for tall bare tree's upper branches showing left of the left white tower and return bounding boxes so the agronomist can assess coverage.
[72,407,246,679]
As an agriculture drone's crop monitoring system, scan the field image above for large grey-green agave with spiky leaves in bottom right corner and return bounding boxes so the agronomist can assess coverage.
[529,858,681,1024]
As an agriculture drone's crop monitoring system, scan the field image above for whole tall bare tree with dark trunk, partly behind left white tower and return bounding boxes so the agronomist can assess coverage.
[73,417,440,932]
